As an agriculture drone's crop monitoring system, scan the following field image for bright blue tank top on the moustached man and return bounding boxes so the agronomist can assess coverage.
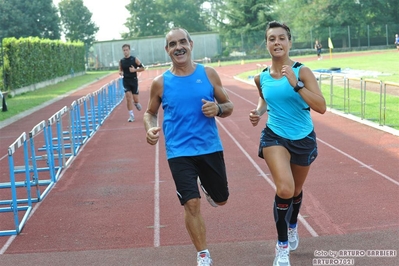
[162,64,223,159]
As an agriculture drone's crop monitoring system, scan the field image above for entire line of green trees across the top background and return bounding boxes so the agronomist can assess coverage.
[0,0,399,47]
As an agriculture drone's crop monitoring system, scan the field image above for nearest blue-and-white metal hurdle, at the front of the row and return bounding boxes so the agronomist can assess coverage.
[0,132,32,236]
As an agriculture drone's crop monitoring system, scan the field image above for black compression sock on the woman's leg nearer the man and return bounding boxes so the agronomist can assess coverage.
[273,194,292,242]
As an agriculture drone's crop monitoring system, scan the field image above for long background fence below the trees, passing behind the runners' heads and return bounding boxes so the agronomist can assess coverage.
[88,24,399,69]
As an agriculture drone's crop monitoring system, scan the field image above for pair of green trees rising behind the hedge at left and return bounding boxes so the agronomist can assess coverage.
[0,0,99,47]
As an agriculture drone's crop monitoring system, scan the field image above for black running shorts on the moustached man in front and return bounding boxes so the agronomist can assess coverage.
[168,151,229,205]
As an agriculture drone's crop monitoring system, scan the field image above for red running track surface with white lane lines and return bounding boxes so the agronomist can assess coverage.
[0,51,399,266]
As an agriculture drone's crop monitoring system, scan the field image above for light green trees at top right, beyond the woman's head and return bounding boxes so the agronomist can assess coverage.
[276,0,399,46]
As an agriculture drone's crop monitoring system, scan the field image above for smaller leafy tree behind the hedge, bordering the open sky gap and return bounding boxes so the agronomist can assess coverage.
[58,0,99,47]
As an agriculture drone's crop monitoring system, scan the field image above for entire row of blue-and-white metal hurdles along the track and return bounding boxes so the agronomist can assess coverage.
[0,79,124,236]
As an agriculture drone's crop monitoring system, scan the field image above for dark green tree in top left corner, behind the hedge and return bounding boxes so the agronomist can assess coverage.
[0,0,61,40]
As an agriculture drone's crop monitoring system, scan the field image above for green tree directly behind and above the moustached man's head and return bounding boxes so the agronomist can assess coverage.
[122,0,209,38]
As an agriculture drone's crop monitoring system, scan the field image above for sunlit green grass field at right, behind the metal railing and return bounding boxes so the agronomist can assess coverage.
[239,50,399,129]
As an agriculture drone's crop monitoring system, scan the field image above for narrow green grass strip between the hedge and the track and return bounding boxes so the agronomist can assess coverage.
[0,71,115,121]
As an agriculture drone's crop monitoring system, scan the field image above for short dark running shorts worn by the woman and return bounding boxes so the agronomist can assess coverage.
[258,126,318,166]
